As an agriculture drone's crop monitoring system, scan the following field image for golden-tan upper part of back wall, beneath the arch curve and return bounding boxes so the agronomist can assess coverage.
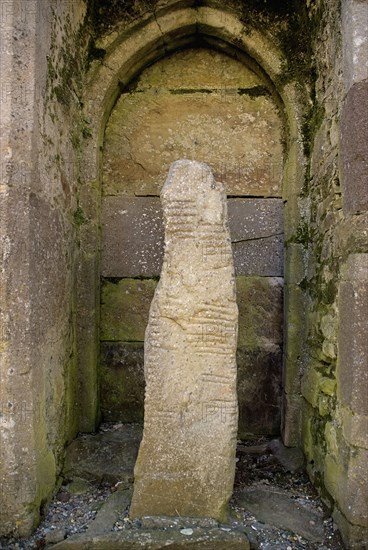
[103,48,282,196]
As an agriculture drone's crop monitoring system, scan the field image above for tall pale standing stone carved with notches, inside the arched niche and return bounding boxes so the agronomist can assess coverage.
[131,160,238,521]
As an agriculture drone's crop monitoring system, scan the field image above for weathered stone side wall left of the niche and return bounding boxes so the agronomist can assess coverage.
[0,0,86,535]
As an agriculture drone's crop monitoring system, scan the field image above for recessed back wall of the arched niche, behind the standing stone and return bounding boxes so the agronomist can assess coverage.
[100,48,283,436]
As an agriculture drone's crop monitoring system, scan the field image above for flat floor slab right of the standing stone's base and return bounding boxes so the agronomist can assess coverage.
[235,487,324,542]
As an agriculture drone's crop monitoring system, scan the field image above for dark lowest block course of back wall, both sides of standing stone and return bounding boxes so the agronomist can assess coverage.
[100,342,282,439]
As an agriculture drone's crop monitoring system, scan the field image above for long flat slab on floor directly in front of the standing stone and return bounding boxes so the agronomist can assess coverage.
[53,527,250,550]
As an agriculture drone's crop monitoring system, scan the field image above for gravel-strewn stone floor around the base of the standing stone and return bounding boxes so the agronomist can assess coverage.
[0,424,344,550]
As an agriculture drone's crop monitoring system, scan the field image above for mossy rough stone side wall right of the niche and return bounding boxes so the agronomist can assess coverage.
[298,1,368,548]
